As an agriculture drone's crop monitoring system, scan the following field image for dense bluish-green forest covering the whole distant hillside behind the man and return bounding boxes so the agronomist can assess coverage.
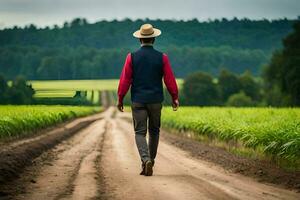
[0,18,295,79]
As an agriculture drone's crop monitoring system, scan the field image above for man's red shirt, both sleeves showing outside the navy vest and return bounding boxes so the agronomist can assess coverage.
[118,53,178,103]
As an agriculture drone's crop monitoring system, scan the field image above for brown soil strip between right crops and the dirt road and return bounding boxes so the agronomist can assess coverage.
[162,131,300,191]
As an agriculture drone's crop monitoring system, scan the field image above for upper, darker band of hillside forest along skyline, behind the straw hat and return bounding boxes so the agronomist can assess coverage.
[0,18,295,50]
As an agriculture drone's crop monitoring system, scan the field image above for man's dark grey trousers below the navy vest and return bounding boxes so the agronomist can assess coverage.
[131,102,162,162]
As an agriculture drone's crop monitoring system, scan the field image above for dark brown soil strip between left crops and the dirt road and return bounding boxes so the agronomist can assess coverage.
[0,113,102,188]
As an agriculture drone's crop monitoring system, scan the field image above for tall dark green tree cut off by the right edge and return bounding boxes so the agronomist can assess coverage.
[264,20,300,106]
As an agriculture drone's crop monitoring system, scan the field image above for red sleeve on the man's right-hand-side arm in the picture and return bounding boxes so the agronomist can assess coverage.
[163,54,178,101]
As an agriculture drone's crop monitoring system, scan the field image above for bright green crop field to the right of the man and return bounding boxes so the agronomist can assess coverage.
[162,107,300,160]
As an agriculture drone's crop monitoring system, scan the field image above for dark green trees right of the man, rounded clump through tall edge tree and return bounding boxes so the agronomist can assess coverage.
[182,21,300,106]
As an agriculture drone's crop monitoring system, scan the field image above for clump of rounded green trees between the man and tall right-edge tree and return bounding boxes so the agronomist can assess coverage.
[181,69,263,107]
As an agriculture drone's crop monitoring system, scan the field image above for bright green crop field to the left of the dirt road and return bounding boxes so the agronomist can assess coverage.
[0,105,101,138]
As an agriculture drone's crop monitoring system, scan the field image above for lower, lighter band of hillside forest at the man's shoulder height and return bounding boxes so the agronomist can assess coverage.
[0,46,270,80]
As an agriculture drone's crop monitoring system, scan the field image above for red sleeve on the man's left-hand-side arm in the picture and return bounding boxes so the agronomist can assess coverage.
[118,53,132,103]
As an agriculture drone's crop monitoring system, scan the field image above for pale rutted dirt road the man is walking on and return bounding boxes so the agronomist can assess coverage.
[2,108,300,200]
